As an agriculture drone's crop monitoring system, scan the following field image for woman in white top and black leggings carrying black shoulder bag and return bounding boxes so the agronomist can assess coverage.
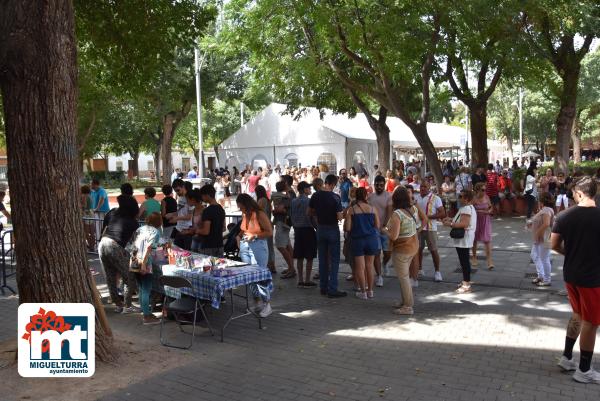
[444,190,477,294]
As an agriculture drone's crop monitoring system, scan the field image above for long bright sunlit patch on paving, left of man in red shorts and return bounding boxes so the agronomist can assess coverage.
[328,314,565,351]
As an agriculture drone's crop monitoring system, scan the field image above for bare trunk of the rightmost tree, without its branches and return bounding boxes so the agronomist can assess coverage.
[554,67,579,175]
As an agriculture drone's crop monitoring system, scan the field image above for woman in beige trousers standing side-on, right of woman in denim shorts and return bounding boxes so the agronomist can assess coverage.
[383,187,419,315]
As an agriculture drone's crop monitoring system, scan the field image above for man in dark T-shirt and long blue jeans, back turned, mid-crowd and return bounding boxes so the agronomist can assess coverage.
[308,174,346,298]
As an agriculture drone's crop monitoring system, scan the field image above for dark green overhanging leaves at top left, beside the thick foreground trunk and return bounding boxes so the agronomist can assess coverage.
[75,0,216,95]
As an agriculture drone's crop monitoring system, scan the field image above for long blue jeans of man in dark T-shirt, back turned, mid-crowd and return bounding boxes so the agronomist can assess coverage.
[317,225,340,294]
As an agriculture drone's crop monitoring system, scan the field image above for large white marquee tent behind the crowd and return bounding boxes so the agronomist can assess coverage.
[219,103,466,171]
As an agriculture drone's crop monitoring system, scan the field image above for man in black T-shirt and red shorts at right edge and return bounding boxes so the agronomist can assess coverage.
[551,177,600,384]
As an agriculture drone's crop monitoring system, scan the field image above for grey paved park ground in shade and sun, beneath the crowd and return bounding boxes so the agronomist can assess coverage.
[0,218,600,401]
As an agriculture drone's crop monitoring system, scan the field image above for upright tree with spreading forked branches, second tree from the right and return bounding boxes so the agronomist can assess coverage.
[442,0,522,165]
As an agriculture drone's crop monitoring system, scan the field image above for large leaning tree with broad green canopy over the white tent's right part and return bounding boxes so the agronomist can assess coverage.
[227,0,442,181]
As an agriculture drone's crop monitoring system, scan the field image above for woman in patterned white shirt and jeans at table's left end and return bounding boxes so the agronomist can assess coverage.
[129,212,162,325]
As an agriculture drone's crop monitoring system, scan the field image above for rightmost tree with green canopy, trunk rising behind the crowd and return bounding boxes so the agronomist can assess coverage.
[525,0,600,172]
